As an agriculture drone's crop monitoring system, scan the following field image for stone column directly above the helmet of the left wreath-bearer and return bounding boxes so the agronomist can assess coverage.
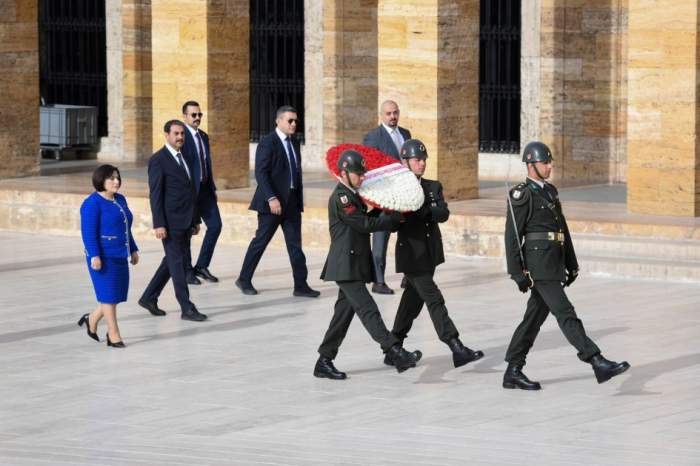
[322,0,378,152]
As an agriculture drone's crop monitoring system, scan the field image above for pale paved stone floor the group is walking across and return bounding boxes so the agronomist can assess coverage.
[0,233,700,466]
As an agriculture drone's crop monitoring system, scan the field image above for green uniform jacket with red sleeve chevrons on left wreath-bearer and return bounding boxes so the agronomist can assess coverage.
[321,183,392,283]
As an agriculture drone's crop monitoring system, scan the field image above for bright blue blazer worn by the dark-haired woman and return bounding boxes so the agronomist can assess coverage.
[80,191,139,259]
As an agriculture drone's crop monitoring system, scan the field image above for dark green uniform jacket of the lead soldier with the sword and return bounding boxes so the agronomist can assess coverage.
[505,179,578,282]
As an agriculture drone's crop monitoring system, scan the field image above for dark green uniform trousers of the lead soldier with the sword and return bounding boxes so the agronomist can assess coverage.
[506,280,600,366]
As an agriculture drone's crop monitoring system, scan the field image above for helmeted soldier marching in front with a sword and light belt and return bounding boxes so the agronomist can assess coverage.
[503,142,630,390]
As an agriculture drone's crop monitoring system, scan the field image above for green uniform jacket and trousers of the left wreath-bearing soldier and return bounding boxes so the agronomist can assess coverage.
[318,183,398,359]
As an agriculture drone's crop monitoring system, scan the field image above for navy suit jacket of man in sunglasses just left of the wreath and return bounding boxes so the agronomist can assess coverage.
[248,131,304,214]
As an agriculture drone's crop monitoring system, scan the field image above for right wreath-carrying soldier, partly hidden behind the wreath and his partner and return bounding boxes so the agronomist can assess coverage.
[384,139,484,367]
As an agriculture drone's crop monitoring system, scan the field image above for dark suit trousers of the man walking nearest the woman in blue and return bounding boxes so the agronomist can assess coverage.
[141,228,195,312]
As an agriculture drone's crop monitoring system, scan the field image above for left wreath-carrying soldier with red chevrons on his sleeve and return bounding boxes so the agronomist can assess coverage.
[314,149,422,380]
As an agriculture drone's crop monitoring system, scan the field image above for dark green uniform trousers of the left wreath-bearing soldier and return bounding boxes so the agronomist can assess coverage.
[318,281,399,359]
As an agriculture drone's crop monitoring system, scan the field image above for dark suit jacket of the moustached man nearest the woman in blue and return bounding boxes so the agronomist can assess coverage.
[148,146,201,230]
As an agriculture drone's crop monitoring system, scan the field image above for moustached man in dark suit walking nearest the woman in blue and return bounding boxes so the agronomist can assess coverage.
[139,120,207,321]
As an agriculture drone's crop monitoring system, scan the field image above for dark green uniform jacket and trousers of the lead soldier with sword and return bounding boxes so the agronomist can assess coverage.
[505,177,600,366]
